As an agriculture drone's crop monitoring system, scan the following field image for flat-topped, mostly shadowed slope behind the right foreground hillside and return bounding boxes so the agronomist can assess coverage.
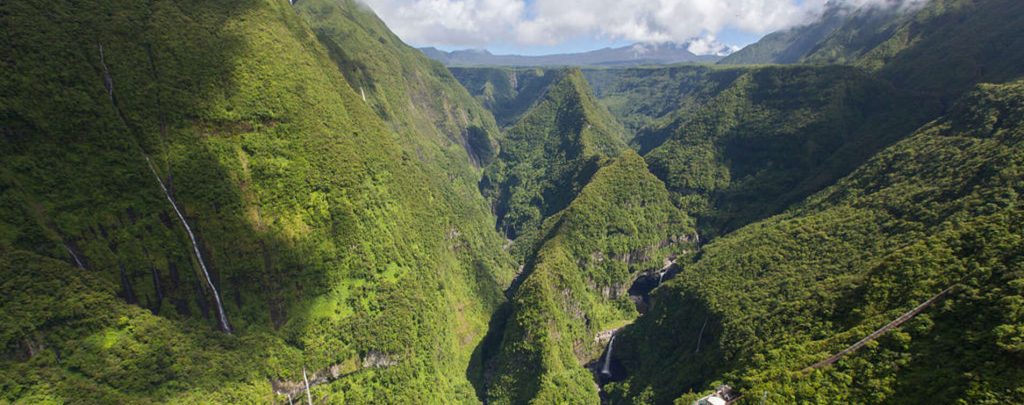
[634,66,936,234]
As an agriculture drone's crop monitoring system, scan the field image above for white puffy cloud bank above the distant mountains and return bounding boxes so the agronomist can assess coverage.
[364,0,927,53]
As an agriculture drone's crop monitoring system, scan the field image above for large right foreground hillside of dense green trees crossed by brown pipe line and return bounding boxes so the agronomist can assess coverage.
[606,82,1024,404]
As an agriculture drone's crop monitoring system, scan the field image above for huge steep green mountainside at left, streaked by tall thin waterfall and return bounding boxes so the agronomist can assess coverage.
[0,0,514,403]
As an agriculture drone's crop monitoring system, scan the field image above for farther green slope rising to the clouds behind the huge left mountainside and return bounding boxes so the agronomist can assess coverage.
[295,0,498,166]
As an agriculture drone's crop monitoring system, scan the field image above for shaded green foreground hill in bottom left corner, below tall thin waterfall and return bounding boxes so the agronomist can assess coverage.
[0,248,303,404]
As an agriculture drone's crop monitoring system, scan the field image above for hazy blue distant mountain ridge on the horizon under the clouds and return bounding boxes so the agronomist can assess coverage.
[420,43,731,66]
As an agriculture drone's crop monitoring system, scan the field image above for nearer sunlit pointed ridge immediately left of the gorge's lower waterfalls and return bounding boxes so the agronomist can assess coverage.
[487,151,693,404]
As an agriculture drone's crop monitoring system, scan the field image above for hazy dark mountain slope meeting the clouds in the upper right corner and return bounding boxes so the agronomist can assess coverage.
[720,0,1024,104]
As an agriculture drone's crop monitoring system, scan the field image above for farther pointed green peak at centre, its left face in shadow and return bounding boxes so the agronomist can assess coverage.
[480,70,626,249]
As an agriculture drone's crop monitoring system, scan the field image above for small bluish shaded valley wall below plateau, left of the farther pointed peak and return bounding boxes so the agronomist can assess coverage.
[449,68,561,128]
